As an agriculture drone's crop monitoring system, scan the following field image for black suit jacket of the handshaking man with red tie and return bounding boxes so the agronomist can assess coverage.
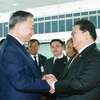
[55,43,100,100]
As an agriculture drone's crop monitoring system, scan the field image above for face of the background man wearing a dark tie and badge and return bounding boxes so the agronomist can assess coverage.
[28,41,39,55]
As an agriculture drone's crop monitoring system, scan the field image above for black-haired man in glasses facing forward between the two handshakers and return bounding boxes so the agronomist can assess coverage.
[44,39,67,100]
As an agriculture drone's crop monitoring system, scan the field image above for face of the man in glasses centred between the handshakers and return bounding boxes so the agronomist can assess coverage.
[51,41,64,57]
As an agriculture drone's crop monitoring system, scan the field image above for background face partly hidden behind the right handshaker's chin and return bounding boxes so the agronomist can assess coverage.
[66,41,75,57]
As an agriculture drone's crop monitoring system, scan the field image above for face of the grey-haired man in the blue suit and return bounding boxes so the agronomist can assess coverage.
[19,17,34,43]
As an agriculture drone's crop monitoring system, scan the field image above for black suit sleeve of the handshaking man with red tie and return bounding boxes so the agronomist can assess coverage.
[55,54,100,96]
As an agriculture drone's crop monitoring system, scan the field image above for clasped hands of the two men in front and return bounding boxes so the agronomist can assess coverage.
[42,74,57,94]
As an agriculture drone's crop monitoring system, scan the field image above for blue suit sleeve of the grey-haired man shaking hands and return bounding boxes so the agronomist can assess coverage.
[2,48,50,92]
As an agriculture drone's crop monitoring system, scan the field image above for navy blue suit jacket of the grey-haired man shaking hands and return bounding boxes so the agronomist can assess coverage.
[0,35,50,100]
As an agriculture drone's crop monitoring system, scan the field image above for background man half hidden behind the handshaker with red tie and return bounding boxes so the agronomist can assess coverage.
[52,38,77,80]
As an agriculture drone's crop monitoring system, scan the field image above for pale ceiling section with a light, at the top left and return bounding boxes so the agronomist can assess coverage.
[0,0,82,14]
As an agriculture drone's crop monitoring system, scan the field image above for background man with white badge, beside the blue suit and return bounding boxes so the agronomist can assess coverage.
[28,39,47,77]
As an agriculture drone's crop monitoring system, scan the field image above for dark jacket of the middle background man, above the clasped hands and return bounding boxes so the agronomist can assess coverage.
[44,56,67,77]
